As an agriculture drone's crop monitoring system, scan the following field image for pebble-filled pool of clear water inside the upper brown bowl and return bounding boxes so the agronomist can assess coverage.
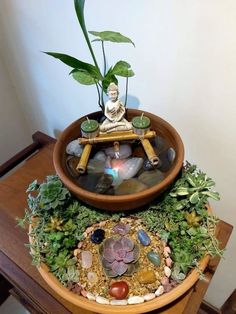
[66,135,176,195]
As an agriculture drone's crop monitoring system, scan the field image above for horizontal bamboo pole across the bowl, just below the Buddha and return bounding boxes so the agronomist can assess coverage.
[78,131,156,145]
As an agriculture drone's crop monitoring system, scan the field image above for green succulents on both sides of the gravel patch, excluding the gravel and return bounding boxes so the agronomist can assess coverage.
[19,164,222,284]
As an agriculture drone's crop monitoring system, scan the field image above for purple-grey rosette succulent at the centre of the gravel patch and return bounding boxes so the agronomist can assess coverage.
[99,237,139,277]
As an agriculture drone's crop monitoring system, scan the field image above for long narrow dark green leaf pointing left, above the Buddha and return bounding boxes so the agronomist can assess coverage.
[45,52,103,80]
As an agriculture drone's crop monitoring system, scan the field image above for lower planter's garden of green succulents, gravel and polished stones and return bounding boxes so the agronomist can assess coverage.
[19,163,222,305]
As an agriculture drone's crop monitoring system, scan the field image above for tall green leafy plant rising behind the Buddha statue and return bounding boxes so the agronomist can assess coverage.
[45,0,134,111]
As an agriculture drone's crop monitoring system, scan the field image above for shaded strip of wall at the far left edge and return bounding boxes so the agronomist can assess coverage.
[0,23,32,164]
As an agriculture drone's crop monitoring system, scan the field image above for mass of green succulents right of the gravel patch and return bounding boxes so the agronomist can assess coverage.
[137,163,222,281]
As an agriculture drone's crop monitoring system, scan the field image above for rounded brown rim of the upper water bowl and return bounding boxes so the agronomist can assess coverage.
[53,109,184,210]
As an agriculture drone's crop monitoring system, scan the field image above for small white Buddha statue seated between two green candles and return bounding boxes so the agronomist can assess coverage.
[100,83,132,133]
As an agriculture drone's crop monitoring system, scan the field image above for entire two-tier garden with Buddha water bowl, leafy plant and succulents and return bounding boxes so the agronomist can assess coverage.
[19,0,222,306]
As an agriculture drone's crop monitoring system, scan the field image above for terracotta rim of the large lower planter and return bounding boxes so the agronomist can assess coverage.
[29,206,212,314]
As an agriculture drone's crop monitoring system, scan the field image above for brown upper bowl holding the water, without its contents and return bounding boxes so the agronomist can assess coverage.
[53,109,184,211]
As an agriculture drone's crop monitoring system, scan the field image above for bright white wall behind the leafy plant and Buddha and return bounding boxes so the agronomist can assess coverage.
[0,0,236,307]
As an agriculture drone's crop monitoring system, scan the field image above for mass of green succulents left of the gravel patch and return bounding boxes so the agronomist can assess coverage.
[18,176,121,284]
